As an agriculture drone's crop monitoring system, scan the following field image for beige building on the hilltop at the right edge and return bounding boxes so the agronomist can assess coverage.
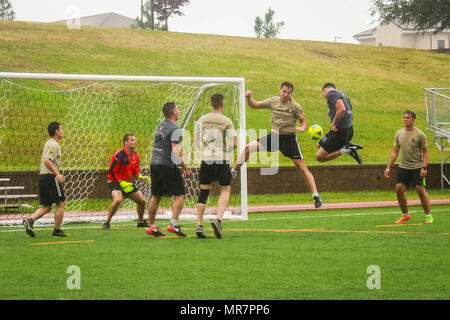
[353,22,450,50]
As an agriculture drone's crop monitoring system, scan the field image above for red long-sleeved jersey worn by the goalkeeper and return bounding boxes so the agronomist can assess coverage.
[108,148,141,182]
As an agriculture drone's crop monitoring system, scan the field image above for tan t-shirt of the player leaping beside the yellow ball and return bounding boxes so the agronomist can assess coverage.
[261,97,305,133]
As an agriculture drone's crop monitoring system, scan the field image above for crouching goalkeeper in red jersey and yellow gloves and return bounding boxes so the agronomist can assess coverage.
[103,133,150,230]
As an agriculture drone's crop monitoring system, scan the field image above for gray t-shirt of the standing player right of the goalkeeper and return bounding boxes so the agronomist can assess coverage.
[150,120,183,168]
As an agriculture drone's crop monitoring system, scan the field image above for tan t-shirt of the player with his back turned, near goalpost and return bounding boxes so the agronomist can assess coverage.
[195,112,236,161]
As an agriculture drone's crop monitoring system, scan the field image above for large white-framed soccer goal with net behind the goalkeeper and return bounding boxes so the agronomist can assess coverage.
[0,72,247,225]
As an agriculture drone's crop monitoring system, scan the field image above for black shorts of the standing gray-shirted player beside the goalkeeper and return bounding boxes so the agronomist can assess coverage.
[150,165,186,197]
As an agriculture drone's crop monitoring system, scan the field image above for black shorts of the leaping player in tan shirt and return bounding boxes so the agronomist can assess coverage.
[258,132,303,159]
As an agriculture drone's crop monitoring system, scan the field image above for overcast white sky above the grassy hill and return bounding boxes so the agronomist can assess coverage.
[10,0,374,43]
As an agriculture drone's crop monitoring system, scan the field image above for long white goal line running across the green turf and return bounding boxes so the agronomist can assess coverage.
[0,209,450,233]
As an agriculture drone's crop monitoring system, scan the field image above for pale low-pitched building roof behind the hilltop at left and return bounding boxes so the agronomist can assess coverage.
[54,12,136,28]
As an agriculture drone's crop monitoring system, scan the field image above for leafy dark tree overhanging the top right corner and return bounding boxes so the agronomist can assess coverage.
[371,0,450,33]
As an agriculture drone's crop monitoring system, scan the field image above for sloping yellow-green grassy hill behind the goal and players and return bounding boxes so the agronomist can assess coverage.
[0,21,450,165]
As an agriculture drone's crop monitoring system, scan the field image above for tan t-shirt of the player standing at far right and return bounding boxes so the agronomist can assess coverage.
[394,128,428,169]
